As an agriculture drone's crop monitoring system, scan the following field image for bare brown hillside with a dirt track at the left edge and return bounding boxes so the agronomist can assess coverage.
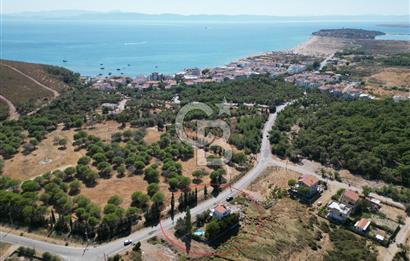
[0,60,73,114]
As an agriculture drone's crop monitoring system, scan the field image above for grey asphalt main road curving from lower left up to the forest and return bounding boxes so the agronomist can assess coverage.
[0,105,286,261]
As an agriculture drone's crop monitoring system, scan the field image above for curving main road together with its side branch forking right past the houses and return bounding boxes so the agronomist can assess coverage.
[0,104,410,261]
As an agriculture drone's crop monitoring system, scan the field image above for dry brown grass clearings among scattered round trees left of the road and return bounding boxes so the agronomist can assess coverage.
[4,121,245,211]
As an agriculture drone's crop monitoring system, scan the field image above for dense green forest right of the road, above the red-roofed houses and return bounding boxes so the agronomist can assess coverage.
[270,93,410,187]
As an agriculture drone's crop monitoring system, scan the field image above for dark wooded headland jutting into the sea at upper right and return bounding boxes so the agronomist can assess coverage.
[313,28,385,40]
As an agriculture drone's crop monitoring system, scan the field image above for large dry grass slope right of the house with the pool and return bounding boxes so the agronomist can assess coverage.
[210,198,330,260]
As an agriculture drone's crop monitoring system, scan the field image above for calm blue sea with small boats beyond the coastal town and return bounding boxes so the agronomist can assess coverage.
[1,19,410,76]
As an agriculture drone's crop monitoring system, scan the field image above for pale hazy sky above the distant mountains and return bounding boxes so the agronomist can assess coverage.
[0,0,410,16]
